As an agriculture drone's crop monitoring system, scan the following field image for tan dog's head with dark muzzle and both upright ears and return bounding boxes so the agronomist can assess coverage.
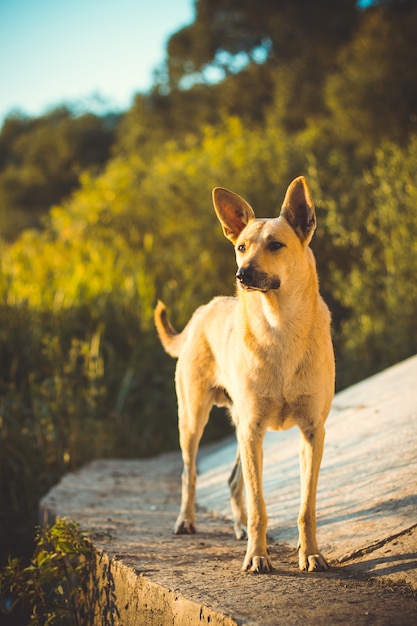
[213,176,316,293]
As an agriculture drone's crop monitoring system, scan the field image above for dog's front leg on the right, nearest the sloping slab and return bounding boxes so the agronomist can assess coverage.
[298,424,329,572]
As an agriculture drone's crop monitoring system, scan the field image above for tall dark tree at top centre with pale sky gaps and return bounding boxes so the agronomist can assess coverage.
[142,0,358,130]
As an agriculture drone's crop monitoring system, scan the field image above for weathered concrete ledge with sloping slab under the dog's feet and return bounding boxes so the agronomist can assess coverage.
[40,358,417,626]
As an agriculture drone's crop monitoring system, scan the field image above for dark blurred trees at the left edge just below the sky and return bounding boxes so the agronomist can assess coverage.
[0,108,114,240]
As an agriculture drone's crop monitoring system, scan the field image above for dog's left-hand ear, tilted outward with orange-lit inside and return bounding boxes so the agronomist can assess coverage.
[213,187,255,243]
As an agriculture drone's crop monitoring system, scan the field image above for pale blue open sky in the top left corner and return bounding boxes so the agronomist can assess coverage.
[0,0,194,125]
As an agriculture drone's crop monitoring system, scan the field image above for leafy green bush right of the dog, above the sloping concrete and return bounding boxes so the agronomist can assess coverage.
[334,136,417,377]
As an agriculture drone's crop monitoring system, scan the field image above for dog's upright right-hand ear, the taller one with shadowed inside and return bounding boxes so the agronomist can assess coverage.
[281,176,316,243]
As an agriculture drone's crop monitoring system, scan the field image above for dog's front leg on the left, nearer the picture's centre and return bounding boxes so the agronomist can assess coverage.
[237,422,272,573]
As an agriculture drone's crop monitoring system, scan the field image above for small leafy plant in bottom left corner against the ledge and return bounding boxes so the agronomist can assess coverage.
[0,519,96,626]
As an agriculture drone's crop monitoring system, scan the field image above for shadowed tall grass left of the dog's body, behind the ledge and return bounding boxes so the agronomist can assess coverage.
[0,301,177,555]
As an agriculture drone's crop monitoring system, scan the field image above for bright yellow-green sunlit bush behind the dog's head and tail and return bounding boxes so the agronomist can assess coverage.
[3,118,288,324]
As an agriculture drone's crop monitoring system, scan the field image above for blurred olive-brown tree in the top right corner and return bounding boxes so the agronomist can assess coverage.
[326,2,417,152]
